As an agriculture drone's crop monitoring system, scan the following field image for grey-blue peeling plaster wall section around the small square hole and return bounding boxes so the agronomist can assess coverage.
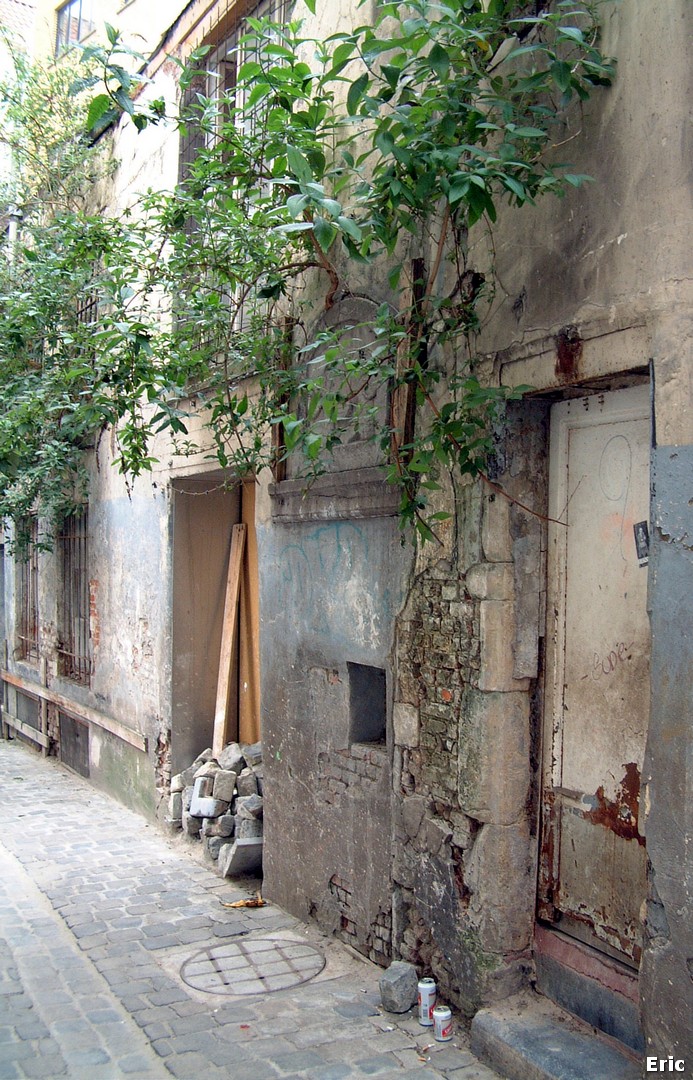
[258,503,411,963]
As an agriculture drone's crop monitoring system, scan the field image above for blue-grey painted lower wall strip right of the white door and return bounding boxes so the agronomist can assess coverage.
[641,446,693,1057]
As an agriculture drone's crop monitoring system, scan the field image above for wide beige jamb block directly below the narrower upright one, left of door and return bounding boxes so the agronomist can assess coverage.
[458,690,530,825]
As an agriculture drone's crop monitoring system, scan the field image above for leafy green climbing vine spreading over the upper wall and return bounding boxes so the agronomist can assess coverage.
[0,0,614,538]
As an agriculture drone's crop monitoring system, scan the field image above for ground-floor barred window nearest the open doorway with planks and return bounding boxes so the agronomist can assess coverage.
[58,510,92,685]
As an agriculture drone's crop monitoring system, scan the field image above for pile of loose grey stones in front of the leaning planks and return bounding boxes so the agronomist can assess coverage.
[168,742,262,877]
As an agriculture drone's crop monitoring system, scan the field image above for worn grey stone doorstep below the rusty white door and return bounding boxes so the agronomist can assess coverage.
[472,994,642,1080]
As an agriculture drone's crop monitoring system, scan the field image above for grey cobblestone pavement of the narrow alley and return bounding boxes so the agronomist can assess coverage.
[0,741,495,1080]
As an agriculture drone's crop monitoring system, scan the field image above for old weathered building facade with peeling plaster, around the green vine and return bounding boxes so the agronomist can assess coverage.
[3,0,693,1062]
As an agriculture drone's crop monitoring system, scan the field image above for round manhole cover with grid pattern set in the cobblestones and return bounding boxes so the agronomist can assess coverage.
[180,937,325,995]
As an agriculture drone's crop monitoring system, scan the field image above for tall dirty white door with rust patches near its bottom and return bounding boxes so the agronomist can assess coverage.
[539,387,650,963]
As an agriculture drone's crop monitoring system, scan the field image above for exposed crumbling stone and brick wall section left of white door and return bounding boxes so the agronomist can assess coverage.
[394,405,546,1014]
